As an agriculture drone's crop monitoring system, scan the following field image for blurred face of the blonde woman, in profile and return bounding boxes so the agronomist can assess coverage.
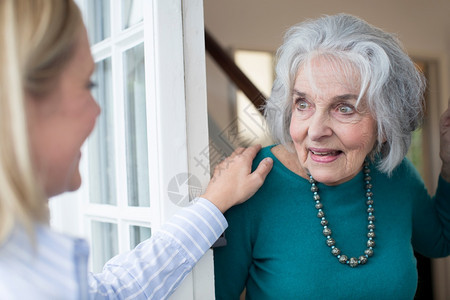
[27,29,100,197]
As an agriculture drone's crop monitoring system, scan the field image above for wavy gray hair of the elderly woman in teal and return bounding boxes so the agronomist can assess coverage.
[264,14,425,174]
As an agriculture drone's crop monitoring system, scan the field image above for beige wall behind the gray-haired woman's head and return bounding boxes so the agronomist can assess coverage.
[204,0,450,125]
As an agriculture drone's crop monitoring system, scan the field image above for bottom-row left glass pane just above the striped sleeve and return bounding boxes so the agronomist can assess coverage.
[91,221,119,273]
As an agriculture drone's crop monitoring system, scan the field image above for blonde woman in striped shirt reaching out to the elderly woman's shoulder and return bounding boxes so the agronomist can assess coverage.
[0,0,272,299]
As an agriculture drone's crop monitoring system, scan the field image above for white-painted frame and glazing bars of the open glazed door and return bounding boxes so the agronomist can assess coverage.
[51,0,214,300]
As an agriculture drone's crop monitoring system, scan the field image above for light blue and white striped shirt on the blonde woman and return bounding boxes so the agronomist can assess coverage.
[0,198,228,300]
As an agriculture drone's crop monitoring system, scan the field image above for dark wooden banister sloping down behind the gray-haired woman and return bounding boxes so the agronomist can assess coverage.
[205,29,266,111]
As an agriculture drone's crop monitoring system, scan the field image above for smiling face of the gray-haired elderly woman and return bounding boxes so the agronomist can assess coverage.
[290,58,377,185]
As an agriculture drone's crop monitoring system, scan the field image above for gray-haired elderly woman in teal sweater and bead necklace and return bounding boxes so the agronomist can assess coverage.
[215,15,450,300]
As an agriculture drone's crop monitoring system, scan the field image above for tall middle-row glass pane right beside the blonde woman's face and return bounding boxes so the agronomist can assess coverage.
[89,58,117,205]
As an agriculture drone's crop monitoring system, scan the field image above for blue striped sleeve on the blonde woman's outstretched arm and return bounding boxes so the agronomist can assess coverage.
[89,198,228,299]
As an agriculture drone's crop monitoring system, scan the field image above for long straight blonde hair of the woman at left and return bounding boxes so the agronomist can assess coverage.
[0,0,83,244]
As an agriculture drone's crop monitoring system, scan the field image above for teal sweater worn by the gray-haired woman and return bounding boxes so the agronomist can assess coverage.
[214,147,450,300]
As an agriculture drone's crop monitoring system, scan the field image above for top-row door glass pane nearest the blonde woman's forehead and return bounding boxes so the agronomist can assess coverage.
[86,0,111,44]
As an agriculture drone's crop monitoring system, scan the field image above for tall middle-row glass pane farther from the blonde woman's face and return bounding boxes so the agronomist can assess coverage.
[124,44,150,206]
